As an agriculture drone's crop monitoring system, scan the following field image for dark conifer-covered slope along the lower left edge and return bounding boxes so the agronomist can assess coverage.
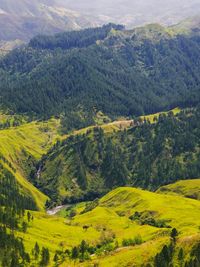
[0,164,49,267]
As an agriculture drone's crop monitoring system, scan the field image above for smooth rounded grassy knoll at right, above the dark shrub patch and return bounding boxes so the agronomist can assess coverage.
[101,188,200,236]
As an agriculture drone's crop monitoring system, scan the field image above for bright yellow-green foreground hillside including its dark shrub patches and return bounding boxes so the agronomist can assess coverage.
[13,188,200,267]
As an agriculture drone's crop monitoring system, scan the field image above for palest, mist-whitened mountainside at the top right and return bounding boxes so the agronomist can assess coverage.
[56,0,200,28]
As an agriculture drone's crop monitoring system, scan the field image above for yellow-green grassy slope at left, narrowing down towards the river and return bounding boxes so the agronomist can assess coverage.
[0,113,132,209]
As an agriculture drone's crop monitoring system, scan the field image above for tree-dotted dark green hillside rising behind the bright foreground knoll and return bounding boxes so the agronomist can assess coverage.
[32,108,200,206]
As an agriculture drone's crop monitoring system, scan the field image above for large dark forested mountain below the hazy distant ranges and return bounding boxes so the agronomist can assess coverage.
[0,24,200,130]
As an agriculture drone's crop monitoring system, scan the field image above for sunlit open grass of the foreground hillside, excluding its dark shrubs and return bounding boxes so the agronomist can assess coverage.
[16,188,200,267]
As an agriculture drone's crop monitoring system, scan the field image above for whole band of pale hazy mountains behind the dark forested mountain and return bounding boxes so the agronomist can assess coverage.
[0,0,200,49]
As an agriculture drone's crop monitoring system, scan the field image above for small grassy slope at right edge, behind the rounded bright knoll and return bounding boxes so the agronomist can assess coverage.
[158,179,200,200]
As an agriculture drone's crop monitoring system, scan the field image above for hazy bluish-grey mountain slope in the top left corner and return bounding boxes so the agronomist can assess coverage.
[0,0,101,46]
